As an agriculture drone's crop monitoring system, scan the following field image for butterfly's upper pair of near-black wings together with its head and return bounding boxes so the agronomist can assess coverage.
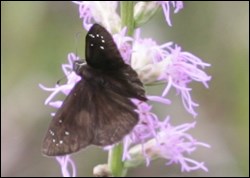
[84,24,147,101]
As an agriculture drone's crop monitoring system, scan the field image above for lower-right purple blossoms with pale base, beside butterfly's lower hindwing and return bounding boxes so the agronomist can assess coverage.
[123,101,210,172]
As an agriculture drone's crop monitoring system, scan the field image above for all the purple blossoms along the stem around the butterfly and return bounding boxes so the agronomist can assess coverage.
[40,1,211,176]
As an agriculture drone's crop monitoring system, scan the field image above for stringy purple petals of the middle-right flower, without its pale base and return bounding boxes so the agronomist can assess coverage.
[159,45,211,117]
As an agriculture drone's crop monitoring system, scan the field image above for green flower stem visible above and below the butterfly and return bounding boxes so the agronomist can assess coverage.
[108,1,135,177]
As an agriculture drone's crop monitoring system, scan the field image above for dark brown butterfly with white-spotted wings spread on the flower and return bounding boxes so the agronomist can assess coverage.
[42,24,147,156]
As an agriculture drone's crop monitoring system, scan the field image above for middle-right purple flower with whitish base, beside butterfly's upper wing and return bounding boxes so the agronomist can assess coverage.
[131,30,211,117]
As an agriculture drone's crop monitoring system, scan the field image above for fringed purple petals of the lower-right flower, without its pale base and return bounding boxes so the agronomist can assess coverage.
[156,117,210,172]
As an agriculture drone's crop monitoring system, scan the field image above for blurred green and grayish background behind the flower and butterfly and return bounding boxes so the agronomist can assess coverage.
[1,1,249,176]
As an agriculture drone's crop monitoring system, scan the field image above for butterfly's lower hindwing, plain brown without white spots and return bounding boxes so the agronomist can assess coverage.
[90,82,138,146]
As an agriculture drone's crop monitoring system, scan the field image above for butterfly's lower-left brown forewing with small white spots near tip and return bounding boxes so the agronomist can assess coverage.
[42,80,93,156]
